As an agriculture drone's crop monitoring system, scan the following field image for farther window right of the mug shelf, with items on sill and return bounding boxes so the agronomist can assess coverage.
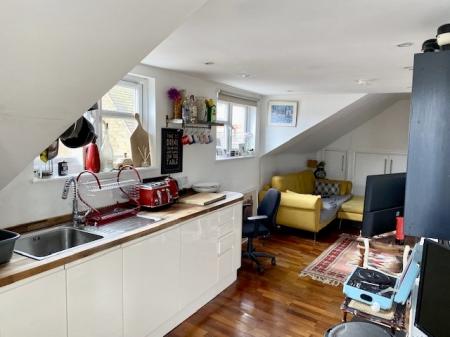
[216,94,256,159]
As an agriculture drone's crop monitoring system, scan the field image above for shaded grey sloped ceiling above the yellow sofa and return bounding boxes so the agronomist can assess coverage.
[264,93,410,156]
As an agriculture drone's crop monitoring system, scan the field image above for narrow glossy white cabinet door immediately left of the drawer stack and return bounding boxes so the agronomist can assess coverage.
[180,212,218,307]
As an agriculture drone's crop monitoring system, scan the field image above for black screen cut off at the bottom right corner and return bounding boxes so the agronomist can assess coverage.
[415,240,450,337]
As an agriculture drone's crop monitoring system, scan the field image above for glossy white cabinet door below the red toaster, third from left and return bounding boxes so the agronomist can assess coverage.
[123,227,181,337]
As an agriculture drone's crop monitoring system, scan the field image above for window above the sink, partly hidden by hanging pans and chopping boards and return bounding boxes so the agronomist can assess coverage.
[34,76,148,176]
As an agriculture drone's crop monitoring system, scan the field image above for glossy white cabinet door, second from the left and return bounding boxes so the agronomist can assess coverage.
[66,247,123,337]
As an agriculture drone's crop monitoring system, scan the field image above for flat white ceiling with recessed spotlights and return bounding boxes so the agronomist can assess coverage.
[144,0,450,95]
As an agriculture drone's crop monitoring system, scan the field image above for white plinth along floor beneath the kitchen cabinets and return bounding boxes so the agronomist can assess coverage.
[147,271,237,337]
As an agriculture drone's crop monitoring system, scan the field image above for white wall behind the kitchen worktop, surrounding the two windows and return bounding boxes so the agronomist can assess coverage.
[0,65,259,227]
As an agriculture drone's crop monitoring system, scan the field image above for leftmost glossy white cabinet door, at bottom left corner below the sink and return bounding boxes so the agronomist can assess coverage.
[0,267,67,337]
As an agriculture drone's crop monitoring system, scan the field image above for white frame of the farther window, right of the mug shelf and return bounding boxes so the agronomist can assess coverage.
[216,100,257,161]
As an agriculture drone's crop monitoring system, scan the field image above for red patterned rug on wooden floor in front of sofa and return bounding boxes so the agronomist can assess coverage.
[300,234,402,286]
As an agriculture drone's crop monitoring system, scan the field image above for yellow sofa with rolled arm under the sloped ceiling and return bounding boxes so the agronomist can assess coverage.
[258,170,356,233]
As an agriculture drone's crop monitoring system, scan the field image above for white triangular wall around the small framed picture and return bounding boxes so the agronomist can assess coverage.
[261,94,364,153]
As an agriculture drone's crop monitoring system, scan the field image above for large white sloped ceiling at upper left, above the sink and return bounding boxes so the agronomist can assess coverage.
[0,0,206,189]
